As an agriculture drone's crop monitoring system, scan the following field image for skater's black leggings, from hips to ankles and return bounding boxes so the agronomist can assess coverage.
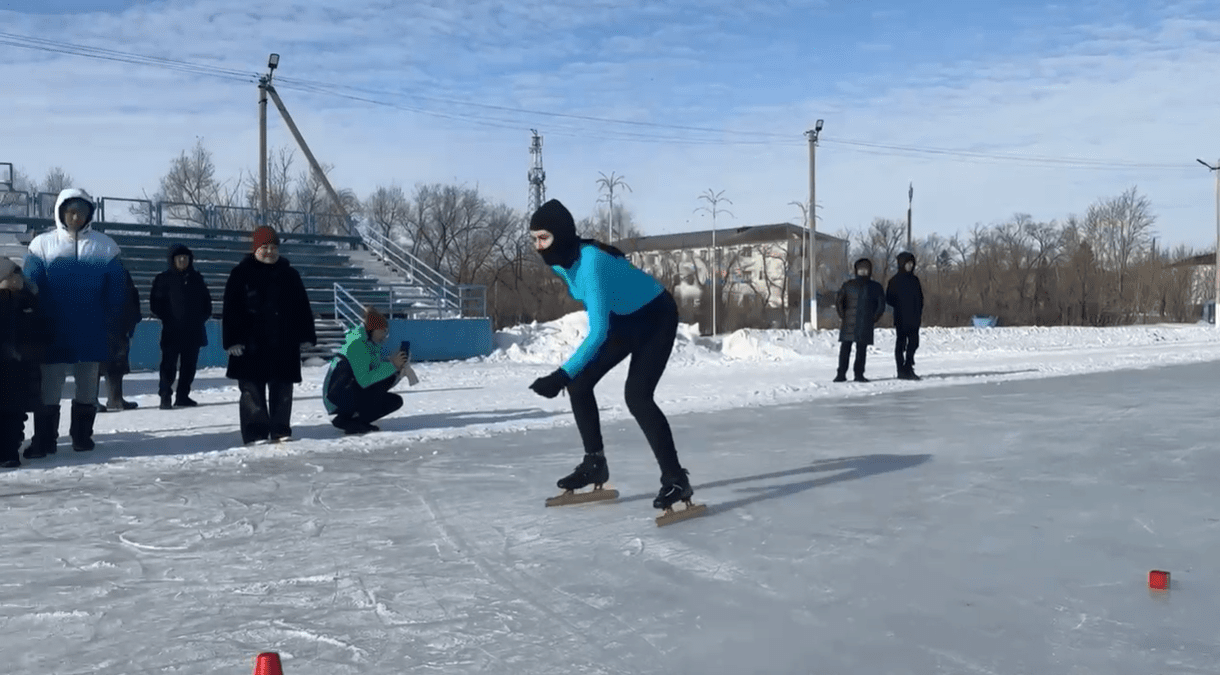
[567,292,682,476]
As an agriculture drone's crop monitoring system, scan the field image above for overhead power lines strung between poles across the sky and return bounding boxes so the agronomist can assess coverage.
[0,32,1193,171]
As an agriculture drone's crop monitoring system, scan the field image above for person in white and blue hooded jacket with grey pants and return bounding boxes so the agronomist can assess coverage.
[23,188,127,458]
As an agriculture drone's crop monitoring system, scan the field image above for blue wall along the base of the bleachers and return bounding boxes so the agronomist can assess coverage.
[129,319,495,370]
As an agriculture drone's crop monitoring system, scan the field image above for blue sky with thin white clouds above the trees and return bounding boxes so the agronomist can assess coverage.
[0,0,1220,247]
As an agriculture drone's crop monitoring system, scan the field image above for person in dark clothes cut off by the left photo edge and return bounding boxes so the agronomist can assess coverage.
[0,258,51,469]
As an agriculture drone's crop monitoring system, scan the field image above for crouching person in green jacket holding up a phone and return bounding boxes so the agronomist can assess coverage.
[322,308,414,433]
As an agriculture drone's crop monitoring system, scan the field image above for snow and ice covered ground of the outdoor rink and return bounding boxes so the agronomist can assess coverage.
[0,314,1220,675]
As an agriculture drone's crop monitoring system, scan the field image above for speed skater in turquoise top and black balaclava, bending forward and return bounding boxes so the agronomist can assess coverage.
[529,199,694,509]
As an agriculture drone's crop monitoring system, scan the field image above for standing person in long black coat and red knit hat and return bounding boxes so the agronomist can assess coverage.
[221,226,317,444]
